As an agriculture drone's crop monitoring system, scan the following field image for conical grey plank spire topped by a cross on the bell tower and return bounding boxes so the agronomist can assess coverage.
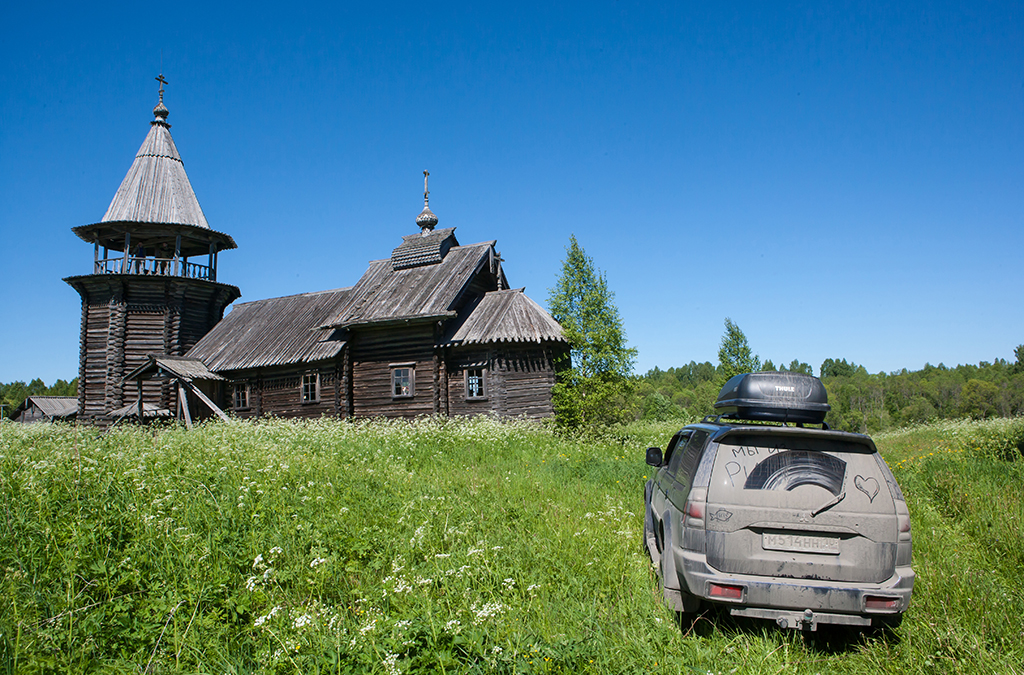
[100,76,210,229]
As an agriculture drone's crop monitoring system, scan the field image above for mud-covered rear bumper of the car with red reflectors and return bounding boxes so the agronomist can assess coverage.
[673,547,914,630]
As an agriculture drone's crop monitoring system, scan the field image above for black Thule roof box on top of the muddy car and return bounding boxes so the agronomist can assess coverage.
[715,372,831,424]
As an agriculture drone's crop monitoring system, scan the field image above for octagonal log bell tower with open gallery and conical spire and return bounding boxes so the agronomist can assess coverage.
[65,75,241,424]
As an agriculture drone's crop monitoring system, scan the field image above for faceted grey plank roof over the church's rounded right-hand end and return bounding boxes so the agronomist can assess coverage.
[447,288,565,344]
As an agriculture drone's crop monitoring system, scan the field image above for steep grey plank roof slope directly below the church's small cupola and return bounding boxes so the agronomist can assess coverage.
[323,241,495,328]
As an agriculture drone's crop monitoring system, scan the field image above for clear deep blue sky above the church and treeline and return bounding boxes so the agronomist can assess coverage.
[0,2,1024,384]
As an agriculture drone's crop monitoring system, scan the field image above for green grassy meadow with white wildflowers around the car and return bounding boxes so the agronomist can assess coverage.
[0,418,1024,675]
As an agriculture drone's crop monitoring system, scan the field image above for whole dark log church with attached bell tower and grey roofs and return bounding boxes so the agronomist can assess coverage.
[65,77,569,425]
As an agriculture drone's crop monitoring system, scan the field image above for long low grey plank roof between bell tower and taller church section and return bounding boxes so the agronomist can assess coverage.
[188,288,352,372]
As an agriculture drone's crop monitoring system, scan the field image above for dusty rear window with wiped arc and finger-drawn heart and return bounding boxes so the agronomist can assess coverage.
[711,434,888,504]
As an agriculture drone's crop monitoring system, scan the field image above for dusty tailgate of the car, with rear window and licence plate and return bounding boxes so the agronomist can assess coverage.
[706,428,897,583]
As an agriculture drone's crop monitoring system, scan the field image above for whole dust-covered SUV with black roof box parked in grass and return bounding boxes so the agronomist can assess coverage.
[644,372,914,631]
